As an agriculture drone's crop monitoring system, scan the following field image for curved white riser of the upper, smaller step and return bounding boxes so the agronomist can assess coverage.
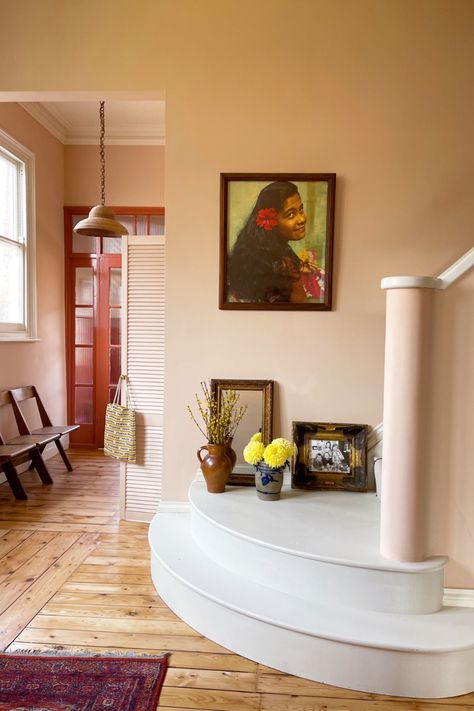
[191,508,444,614]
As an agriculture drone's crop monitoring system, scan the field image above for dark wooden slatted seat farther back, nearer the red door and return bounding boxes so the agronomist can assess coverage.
[9,385,79,472]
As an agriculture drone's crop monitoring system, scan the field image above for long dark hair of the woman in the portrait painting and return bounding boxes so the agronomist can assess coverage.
[227,181,300,303]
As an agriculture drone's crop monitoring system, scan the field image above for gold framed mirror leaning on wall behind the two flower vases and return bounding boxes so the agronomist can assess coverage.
[211,378,274,486]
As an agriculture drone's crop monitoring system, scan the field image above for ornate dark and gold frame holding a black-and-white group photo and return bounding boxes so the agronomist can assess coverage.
[291,422,368,491]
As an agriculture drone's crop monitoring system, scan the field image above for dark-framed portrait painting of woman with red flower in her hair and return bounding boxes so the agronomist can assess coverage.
[219,173,336,311]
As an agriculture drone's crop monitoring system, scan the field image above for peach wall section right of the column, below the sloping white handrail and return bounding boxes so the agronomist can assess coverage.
[426,270,474,587]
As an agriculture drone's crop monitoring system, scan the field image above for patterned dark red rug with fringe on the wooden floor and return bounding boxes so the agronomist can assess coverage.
[0,654,167,711]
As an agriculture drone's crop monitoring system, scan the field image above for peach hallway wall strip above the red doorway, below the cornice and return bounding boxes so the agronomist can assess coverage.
[64,141,165,207]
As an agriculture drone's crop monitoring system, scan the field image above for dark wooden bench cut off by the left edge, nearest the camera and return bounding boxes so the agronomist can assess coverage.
[0,390,60,499]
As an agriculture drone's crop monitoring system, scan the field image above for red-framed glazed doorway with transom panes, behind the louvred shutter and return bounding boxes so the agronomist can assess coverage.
[64,207,164,448]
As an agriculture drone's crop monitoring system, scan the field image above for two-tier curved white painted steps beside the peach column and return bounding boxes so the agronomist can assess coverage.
[150,482,474,698]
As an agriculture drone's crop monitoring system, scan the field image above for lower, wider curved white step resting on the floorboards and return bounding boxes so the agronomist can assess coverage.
[149,513,474,698]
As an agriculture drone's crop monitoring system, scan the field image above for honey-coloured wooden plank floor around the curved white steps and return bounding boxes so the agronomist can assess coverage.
[0,450,474,711]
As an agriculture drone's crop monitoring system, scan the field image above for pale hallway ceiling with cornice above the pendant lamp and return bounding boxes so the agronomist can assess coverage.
[21,101,165,145]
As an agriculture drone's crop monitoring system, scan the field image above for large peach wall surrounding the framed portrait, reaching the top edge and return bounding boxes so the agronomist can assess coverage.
[0,0,474,587]
